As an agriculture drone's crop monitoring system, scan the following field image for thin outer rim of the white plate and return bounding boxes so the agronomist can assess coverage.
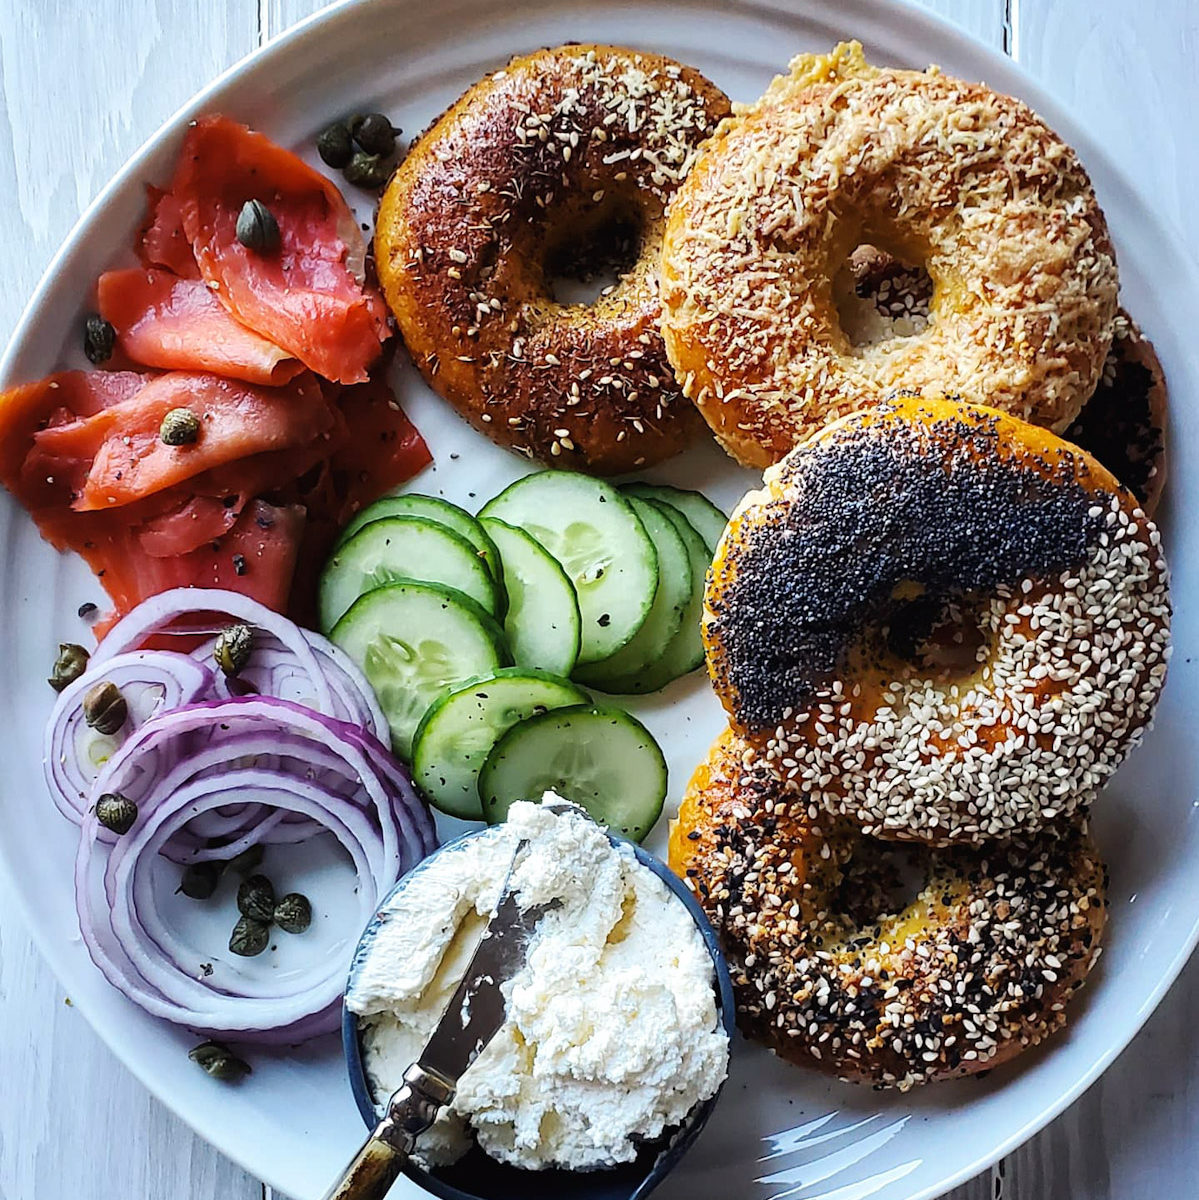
[0,0,1199,1200]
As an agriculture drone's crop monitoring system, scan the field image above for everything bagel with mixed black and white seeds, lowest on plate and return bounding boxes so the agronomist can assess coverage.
[670,731,1105,1090]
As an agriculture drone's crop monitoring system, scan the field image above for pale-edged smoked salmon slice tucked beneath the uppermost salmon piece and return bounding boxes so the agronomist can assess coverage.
[97,266,305,386]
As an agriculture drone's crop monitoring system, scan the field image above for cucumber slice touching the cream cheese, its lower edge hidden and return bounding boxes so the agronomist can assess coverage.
[479,704,666,841]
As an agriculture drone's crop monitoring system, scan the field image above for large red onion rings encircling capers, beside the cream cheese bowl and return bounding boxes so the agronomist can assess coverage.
[76,696,436,1043]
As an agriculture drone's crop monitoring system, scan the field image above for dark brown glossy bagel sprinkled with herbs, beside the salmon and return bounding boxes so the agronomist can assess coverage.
[374,46,729,475]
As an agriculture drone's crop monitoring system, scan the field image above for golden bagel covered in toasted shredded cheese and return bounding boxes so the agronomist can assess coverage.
[661,42,1117,467]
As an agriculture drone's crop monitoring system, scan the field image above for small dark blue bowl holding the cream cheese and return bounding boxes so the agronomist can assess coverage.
[341,829,735,1200]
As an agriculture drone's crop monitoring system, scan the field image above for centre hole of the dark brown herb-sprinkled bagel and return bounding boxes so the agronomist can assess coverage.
[541,192,642,305]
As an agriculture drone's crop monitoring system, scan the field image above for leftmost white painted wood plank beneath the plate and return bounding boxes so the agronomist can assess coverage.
[0,0,260,1200]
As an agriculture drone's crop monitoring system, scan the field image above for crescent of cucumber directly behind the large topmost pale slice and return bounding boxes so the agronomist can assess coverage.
[575,496,695,694]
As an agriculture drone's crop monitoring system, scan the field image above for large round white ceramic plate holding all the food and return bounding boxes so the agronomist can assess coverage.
[0,0,1199,1200]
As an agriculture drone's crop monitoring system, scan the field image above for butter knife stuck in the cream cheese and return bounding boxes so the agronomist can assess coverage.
[325,841,546,1200]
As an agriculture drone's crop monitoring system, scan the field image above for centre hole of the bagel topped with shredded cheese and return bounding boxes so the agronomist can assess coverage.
[833,241,933,350]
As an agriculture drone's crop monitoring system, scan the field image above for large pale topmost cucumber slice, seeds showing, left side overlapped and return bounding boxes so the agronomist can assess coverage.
[479,470,658,662]
